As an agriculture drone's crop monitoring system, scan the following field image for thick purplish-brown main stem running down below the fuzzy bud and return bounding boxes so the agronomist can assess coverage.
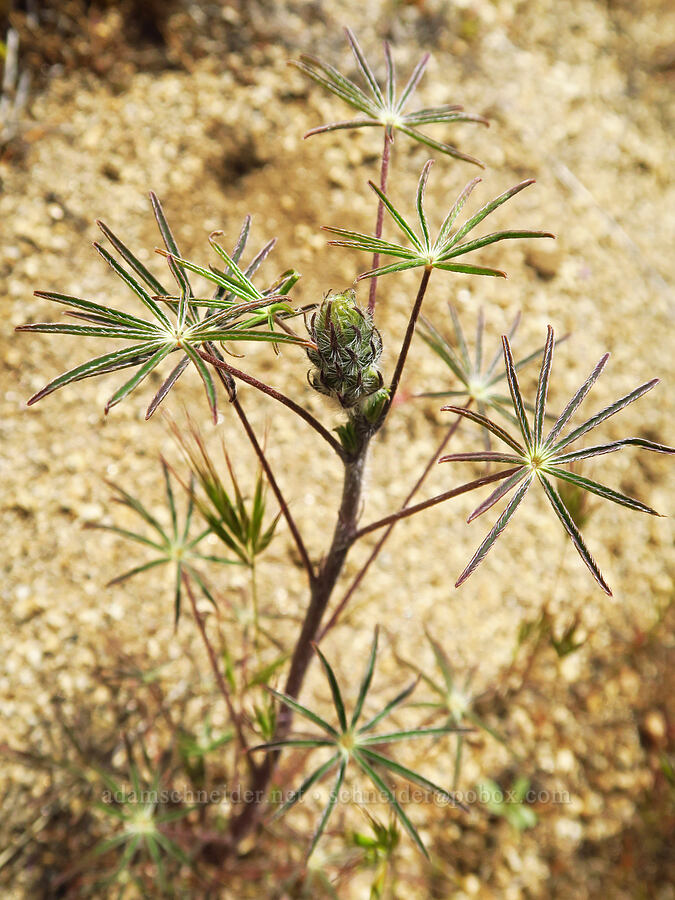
[231,439,368,846]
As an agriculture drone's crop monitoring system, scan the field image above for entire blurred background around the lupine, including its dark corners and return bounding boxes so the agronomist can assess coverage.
[0,0,675,900]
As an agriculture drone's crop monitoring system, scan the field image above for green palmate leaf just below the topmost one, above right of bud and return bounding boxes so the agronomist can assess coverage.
[323,160,554,280]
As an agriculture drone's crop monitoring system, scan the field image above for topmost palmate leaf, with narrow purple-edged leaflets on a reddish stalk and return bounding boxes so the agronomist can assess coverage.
[291,28,489,168]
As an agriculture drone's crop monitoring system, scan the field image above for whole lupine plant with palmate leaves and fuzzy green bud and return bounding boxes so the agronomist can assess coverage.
[19,31,674,880]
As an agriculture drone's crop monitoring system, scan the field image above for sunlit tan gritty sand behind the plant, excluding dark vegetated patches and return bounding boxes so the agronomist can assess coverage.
[0,0,675,898]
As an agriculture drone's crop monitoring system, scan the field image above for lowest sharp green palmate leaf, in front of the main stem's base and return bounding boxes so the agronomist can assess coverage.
[251,628,471,857]
